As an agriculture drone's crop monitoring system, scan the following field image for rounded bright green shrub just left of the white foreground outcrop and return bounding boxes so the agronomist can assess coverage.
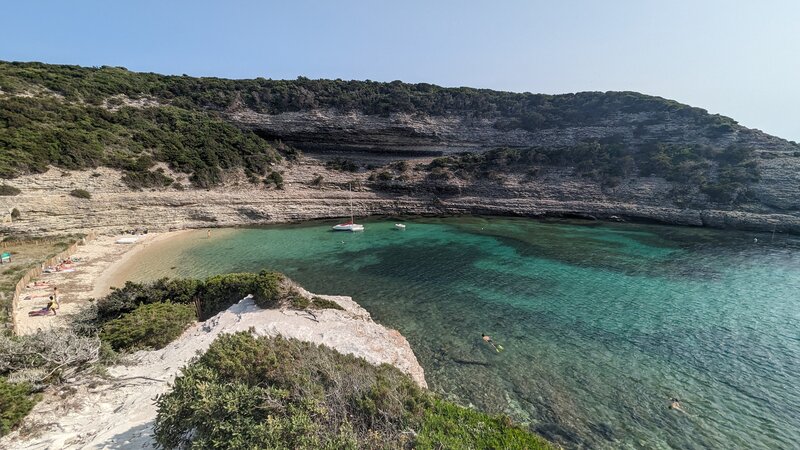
[100,302,196,351]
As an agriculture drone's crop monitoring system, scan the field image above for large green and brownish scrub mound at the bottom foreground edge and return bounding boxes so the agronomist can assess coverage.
[155,333,549,449]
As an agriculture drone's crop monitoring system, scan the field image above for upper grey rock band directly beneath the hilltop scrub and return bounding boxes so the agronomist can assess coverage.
[226,109,800,155]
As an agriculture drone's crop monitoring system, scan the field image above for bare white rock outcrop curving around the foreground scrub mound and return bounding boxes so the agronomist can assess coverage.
[0,291,426,450]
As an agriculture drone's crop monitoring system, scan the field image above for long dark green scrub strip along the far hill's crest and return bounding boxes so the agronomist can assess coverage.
[0,62,735,132]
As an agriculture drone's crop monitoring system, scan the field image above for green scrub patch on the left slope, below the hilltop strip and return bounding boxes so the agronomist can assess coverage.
[0,94,280,188]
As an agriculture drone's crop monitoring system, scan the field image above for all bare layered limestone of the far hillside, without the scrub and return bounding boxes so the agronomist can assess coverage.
[0,107,800,234]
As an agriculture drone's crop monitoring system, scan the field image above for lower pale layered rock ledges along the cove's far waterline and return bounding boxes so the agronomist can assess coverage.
[0,151,800,234]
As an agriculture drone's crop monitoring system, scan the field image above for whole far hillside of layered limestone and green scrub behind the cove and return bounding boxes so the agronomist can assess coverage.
[0,62,800,232]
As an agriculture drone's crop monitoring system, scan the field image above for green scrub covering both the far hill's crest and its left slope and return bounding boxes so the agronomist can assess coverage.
[0,62,752,189]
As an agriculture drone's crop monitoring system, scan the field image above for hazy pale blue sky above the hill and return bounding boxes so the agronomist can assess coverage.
[0,0,800,140]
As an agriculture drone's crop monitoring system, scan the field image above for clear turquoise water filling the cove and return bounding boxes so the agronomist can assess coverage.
[120,218,800,449]
